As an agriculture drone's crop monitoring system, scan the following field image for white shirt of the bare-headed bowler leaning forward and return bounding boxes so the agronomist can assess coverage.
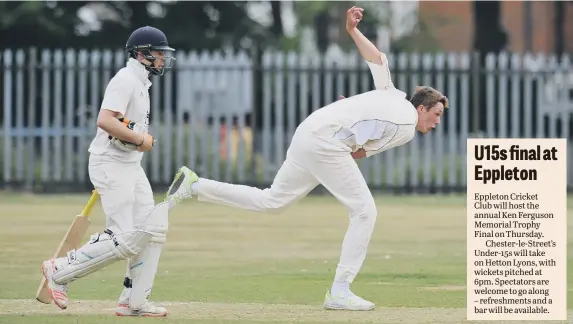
[301,55,418,156]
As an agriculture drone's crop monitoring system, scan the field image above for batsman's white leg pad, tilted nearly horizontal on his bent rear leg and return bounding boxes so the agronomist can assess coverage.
[54,230,152,284]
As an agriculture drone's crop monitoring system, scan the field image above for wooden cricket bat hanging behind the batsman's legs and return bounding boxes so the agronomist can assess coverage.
[36,190,99,304]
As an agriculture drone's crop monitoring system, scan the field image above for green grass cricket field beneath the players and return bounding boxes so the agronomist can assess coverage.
[0,194,573,324]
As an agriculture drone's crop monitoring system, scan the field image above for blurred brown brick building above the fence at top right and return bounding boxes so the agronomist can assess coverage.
[418,1,573,53]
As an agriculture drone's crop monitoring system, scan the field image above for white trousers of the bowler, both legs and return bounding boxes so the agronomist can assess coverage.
[198,127,377,282]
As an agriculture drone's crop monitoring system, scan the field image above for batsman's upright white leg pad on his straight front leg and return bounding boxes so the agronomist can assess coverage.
[129,202,169,310]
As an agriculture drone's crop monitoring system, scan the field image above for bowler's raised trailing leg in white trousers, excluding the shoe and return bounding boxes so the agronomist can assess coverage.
[197,158,318,214]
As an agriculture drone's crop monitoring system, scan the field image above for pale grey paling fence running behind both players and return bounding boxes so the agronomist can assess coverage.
[0,49,573,192]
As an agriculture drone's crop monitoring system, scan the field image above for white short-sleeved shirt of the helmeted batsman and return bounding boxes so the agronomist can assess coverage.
[89,58,151,162]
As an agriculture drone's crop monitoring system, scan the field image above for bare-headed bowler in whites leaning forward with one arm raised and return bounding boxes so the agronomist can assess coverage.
[163,7,448,311]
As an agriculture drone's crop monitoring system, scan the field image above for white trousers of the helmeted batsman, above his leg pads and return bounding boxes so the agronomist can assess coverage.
[88,155,155,233]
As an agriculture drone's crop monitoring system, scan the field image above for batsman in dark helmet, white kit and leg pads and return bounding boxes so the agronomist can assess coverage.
[42,26,185,316]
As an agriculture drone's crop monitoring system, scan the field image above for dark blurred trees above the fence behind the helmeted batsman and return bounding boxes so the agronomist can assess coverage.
[0,1,282,50]
